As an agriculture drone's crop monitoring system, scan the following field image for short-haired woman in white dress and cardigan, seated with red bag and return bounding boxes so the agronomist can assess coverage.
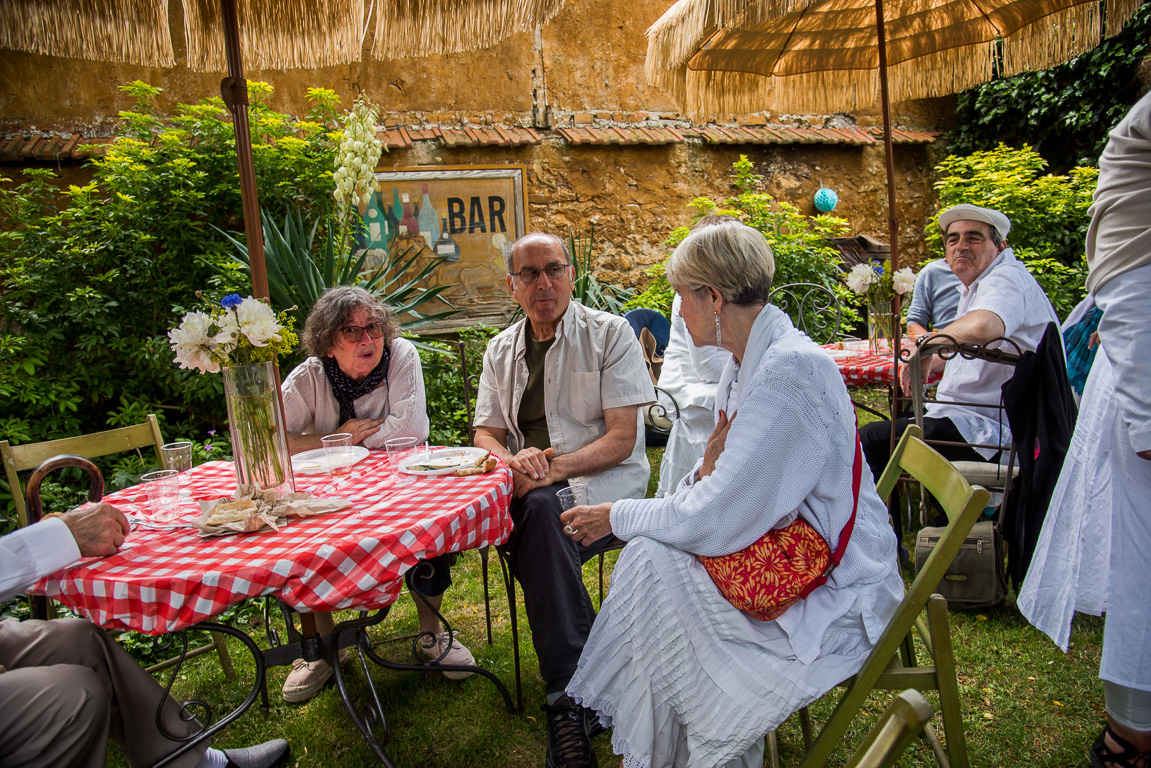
[564,223,904,768]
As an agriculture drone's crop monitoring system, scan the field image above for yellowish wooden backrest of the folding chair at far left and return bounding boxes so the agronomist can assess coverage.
[0,413,163,526]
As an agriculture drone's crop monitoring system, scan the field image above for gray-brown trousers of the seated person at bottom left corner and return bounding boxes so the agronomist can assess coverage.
[0,618,208,768]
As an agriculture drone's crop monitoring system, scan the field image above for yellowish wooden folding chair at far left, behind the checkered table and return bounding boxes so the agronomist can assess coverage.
[0,423,235,679]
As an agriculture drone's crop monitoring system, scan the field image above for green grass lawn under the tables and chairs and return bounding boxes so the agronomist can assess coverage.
[108,405,1104,768]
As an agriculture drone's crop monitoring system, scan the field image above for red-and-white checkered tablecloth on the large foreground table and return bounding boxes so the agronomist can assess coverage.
[36,451,512,634]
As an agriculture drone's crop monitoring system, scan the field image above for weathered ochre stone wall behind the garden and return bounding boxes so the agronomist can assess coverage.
[0,0,952,297]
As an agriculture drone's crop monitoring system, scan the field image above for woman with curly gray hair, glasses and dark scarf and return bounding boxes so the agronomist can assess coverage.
[282,286,475,704]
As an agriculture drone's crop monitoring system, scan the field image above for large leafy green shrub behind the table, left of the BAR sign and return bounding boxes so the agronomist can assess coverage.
[0,82,338,515]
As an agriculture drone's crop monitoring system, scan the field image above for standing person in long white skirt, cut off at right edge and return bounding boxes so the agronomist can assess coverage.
[1019,94,1151,768]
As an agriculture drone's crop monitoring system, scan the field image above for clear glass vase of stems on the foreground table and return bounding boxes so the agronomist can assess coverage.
[223,362,296,493]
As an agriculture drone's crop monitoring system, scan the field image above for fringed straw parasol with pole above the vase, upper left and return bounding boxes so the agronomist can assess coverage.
[0,0,563,297]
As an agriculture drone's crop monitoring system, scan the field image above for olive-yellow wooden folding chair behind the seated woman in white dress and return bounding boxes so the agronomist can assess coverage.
[769,425,990,768]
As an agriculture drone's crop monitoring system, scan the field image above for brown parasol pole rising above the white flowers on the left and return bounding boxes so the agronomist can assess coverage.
[220,0,269,298]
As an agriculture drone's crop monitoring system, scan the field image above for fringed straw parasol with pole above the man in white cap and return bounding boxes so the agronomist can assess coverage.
[647,0,1142,435]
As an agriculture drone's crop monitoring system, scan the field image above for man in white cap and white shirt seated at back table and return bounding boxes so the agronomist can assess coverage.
[860,203,1059,552]
